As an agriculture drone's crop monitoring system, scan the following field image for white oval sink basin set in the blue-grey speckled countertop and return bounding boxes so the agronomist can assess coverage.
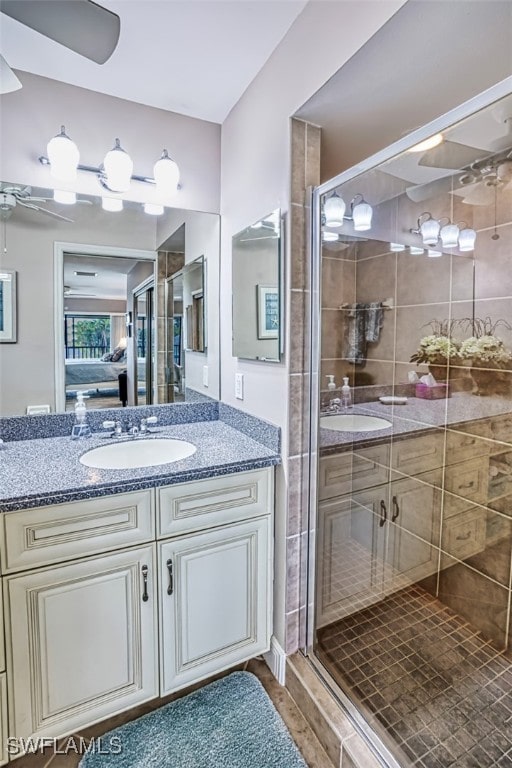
[80,438,196,469]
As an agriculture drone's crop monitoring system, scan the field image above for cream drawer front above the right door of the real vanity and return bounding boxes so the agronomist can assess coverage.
[157,470,274,538]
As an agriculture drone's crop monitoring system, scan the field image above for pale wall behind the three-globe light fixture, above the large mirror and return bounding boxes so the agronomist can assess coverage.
[0,71,220,213]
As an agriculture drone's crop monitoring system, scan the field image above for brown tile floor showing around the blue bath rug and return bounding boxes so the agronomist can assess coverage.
[10,659,333,768]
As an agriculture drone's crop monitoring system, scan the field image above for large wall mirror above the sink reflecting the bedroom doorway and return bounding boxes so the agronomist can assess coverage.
[0,182,220,416]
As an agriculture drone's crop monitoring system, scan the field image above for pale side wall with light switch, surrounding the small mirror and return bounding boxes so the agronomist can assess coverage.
[220,0,404,437]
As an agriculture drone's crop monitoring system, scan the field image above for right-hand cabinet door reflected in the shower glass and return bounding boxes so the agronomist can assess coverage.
[388,478,441,589]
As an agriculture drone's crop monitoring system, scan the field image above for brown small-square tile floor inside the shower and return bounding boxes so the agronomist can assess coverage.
[316,585,512,768]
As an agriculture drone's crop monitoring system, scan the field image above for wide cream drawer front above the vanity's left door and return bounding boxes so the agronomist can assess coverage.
[2,490,155,573]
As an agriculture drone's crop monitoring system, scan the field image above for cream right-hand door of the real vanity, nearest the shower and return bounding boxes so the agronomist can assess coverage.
[159,517,272,696]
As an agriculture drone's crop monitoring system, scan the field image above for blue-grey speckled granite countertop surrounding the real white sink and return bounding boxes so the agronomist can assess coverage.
[0,421,281,512]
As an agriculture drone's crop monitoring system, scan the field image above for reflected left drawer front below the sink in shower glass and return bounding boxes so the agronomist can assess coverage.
[318,445,389,500]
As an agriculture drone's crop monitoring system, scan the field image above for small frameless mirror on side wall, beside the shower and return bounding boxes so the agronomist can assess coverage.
[233,210,283,362]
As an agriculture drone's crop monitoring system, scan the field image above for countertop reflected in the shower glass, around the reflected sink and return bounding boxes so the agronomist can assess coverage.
[319,392,512,454]
